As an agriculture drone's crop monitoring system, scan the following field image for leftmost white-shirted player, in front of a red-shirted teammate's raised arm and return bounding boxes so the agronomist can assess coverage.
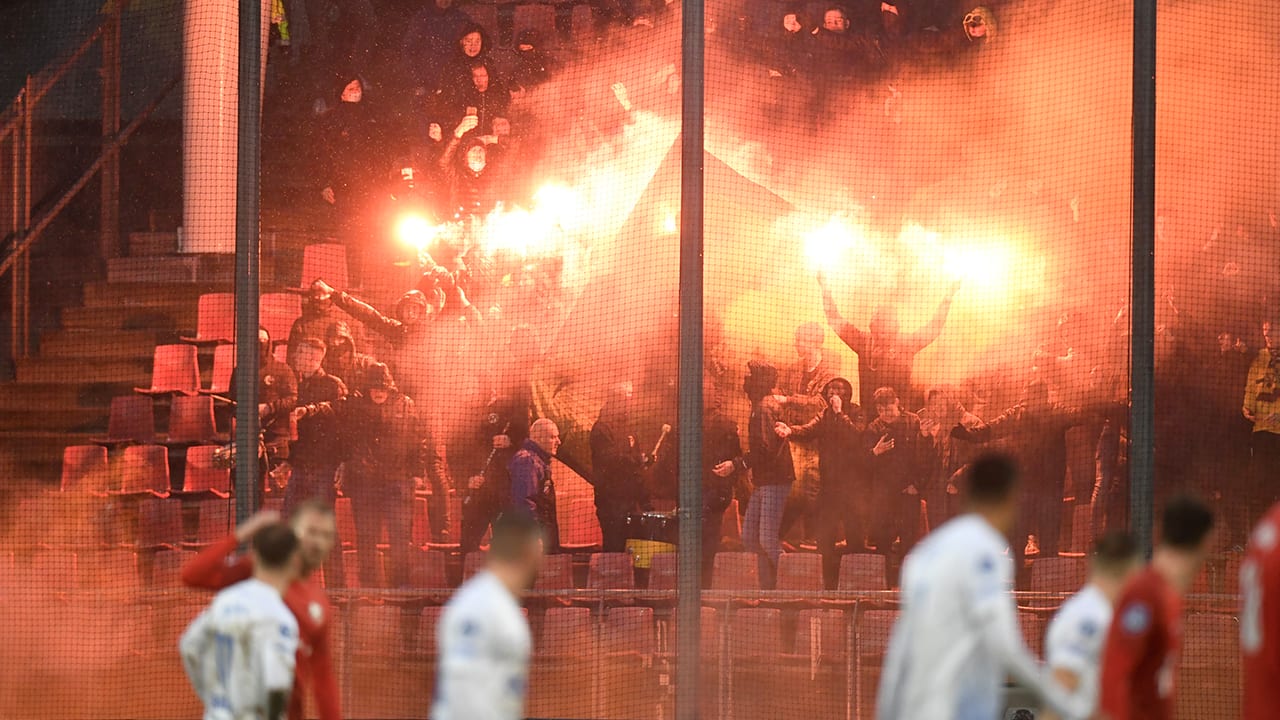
[178,523,300,720]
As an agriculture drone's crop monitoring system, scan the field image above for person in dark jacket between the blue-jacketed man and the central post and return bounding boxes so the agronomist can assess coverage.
[590,382,653,552]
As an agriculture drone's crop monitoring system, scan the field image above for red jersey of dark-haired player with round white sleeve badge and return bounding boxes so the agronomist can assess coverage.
[1101,566,1183,720]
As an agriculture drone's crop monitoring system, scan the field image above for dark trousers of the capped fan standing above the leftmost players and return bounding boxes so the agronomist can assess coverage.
[347,478,413,588]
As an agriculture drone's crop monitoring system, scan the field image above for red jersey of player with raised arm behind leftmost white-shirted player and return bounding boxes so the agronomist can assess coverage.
[182,536,342,720]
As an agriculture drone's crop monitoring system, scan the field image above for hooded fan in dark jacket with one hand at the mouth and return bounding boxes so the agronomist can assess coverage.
[774,378,870,589]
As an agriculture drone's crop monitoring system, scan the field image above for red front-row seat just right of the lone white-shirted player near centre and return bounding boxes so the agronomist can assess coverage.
[529,607,599,717]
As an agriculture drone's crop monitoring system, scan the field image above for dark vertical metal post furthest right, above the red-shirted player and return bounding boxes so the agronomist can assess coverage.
[1129,0,1156,551]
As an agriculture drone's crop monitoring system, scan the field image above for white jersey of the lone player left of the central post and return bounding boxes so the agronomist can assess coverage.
[431,571,532,720]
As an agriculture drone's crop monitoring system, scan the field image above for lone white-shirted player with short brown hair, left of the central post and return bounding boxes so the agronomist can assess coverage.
[431,512,543,720]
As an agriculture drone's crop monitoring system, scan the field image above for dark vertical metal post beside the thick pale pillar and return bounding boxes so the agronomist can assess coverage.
[234,0,264,523]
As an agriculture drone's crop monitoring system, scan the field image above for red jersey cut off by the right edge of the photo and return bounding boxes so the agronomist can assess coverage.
[1240,503,1280,720]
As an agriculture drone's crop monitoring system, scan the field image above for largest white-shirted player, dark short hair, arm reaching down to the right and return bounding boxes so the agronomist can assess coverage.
[876,456,1080,720]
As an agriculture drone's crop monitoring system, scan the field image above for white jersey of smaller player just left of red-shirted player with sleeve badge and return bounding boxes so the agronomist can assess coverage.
[1044,584,1112,720]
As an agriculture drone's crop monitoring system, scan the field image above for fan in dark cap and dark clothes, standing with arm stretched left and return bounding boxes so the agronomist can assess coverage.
[293,363,444,588]
